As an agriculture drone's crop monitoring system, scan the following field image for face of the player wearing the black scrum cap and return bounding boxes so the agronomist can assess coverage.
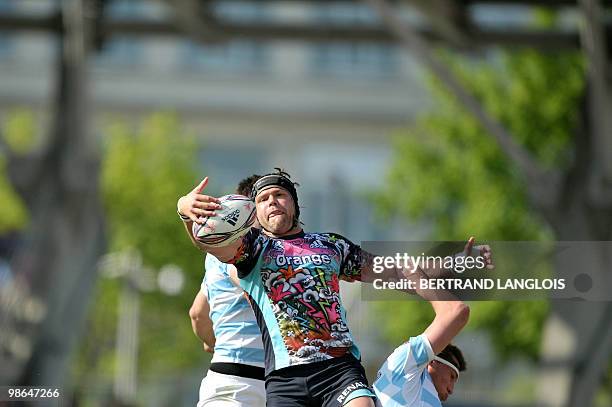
[255,187,295,235]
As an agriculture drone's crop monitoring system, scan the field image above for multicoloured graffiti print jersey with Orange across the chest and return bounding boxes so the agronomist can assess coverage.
[234,229,371,374]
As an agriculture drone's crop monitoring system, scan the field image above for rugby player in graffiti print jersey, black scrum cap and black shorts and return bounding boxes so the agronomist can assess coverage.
[180,170,375,407]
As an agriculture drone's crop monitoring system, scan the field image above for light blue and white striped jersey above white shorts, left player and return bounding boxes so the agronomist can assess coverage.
[202,254,264,367]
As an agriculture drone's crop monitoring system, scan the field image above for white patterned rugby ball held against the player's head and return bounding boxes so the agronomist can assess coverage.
[192,195,257,247]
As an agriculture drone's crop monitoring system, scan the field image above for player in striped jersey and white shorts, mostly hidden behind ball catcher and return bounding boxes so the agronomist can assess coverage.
[184,175,266,407]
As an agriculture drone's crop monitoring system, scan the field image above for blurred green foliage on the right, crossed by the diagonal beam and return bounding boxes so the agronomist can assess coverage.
[377,50,584,358]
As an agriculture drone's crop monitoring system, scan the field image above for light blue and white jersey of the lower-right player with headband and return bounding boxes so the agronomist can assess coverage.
[373,334,442,407]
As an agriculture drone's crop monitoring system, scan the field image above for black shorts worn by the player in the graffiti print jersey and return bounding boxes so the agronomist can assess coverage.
[266,353,375,407]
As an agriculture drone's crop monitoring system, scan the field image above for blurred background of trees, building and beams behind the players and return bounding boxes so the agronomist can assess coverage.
[0,0,612,407]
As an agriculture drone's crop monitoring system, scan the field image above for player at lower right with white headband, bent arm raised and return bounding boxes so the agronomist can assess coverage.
[373,237,492,407]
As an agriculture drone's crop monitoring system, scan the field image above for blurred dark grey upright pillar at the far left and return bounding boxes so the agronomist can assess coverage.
[0,0,105,396]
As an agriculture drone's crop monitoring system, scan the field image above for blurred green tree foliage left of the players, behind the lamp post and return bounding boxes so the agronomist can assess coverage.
[77,114,205,382]
